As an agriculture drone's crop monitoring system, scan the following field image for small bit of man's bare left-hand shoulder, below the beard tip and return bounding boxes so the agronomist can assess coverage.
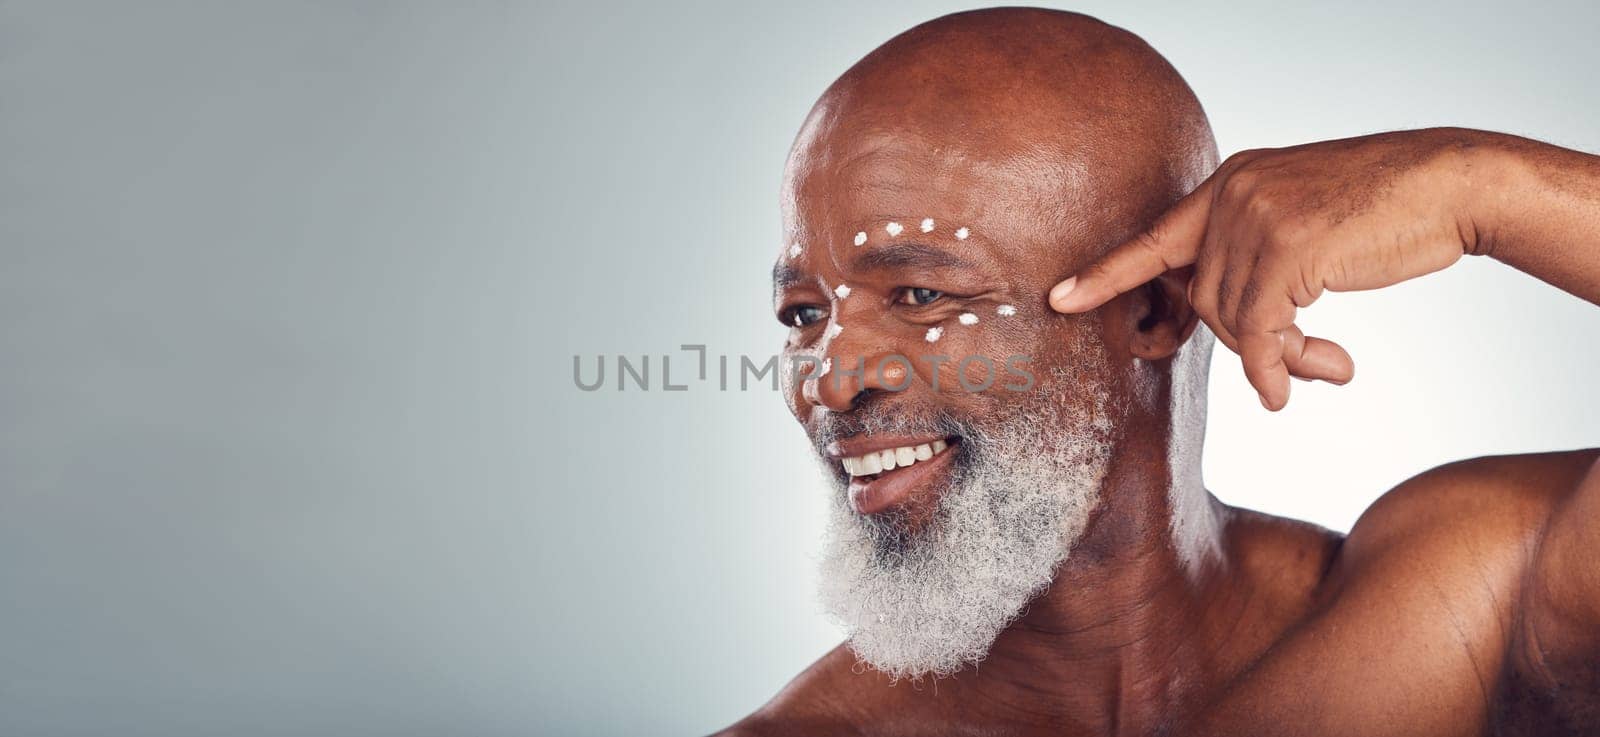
[715,644,862,737]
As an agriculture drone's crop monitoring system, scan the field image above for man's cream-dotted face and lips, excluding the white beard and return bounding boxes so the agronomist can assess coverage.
[774,124,1115,532]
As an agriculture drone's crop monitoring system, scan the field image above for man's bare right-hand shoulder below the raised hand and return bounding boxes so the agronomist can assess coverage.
[1200,449,1600,734]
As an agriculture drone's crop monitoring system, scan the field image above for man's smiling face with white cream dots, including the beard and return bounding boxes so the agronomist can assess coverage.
[774,126,1139,676]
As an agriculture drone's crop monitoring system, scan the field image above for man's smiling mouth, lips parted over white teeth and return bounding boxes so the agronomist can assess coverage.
[832,438,955,515]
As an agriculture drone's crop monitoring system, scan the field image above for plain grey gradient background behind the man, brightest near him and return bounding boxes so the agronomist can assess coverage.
[0,2,1600,737]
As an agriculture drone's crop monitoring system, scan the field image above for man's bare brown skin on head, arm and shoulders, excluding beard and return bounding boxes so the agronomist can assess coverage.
[723,10,1600,735]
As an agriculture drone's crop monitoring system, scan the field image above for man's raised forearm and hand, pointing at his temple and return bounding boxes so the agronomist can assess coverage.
[1050,128,1600,409]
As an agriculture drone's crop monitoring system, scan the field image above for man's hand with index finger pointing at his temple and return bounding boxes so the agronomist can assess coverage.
[1050,129,1486,411]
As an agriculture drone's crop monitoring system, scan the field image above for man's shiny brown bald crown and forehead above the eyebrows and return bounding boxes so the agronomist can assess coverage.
[784,8,1216,273]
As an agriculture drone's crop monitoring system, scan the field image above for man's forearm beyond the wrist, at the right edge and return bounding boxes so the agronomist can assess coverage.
[1464,134,1600,304]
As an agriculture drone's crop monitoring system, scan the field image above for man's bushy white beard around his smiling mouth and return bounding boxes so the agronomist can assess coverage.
[821,376,1114,679]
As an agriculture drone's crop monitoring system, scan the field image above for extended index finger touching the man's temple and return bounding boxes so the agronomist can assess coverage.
[1050,179,1211,313]
